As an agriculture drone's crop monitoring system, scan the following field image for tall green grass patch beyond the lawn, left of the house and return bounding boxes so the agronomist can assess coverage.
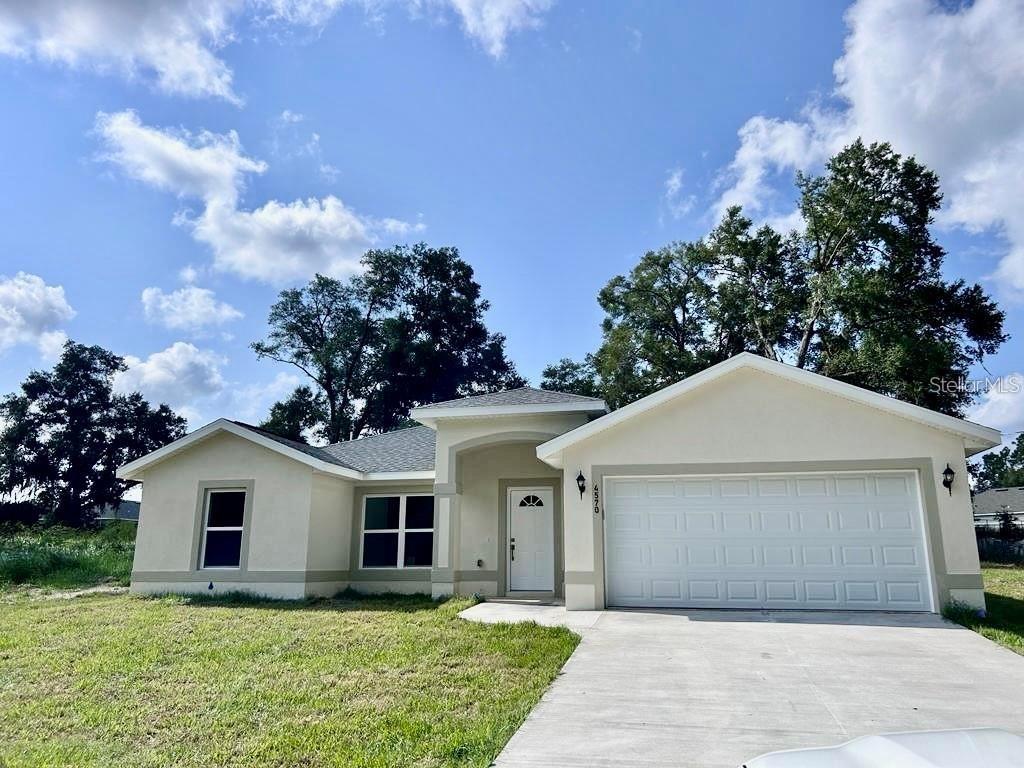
[0,522,135,589]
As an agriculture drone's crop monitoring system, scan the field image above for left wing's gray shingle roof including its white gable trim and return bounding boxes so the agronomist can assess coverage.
[117,419,436,480]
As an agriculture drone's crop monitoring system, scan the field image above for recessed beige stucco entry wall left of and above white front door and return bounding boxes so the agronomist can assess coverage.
[456,442,561,581]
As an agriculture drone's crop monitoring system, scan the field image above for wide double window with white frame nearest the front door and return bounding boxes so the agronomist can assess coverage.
[361,494,434,568]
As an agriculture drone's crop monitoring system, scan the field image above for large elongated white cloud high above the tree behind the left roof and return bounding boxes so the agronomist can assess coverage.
[96,112,423,284]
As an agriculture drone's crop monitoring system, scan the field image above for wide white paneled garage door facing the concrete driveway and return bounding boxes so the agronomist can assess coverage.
[604,472,934,610]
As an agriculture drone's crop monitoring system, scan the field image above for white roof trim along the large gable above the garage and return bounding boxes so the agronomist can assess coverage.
[537,352,1002,467]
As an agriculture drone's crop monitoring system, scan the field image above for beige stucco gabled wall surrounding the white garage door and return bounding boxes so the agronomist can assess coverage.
[562,369,983,608]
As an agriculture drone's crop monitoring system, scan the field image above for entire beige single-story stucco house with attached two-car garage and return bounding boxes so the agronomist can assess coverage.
[118,353,1000,611]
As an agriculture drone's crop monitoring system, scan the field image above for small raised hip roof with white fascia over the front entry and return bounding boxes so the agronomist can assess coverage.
[411,387,608,426]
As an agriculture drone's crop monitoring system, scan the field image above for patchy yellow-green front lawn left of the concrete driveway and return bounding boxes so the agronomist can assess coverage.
[0,592,579,768]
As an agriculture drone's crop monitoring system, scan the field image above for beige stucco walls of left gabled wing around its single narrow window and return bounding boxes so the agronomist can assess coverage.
[132,433,352,597]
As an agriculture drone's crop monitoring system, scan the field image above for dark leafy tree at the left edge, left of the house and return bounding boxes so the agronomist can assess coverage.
[0,341,185,526]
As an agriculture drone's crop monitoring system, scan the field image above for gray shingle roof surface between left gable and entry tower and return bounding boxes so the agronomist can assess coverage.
[234,421,437,472]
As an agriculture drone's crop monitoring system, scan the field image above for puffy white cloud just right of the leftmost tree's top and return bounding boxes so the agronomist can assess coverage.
[114,341,227,420]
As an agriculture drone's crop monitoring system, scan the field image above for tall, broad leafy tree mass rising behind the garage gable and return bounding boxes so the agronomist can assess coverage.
[559,141,1006,415]
